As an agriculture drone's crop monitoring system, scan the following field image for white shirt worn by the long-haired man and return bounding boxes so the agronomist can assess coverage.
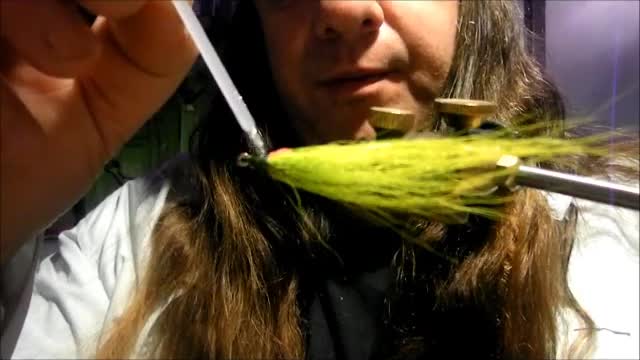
[1,174,640,359]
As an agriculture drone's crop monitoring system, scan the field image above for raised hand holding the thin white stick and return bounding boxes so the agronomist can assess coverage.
[0,0,197,262]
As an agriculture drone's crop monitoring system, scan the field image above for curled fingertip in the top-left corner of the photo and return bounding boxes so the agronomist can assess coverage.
[0,0,99,77]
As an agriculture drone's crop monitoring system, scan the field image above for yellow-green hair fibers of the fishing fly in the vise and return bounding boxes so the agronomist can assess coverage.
[251,133,595,222]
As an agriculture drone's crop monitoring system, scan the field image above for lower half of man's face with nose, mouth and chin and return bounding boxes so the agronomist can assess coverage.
[256,0,458,143]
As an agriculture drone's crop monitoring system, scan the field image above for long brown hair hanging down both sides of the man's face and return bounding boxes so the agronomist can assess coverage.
[97,0,608,359]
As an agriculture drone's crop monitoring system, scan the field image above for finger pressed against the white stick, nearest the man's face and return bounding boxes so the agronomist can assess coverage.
[80,1,198,154]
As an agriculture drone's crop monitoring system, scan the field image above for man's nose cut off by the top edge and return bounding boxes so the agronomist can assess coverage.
[314,0,384,40]
